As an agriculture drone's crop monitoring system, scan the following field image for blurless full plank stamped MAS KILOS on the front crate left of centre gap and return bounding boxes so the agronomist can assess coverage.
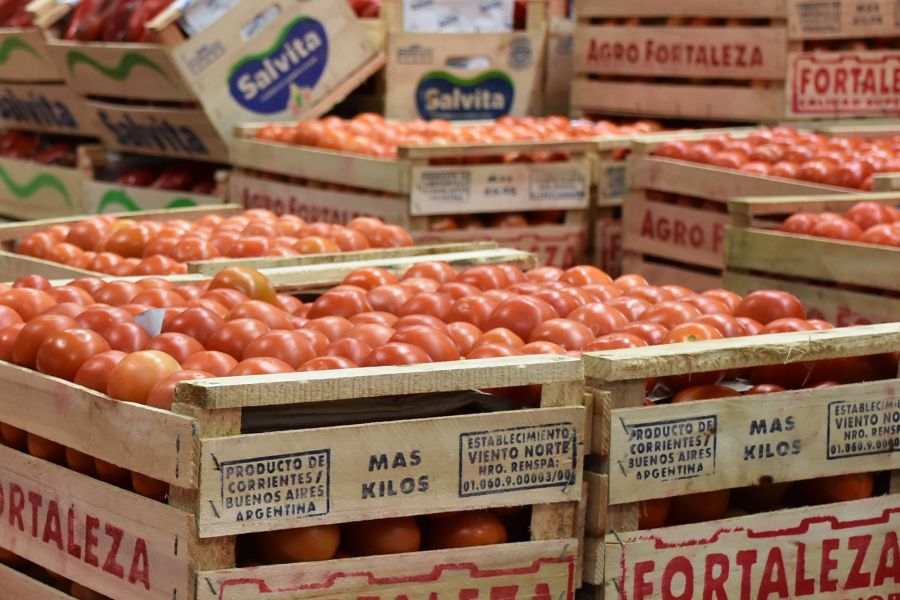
[199,407,584,537]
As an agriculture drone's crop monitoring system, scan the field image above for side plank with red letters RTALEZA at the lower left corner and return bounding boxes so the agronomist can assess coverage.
[0,447,194,600]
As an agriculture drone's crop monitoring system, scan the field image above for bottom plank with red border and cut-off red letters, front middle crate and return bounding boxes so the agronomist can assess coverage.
[197,539,579,600]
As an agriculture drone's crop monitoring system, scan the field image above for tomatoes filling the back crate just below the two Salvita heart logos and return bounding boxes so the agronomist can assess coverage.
[256,113,662,159]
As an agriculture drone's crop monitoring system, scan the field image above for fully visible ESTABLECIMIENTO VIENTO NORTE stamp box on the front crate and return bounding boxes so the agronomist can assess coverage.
[459,423,578,497]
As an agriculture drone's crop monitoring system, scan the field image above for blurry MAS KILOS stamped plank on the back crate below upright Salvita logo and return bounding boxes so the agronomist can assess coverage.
[410,160,591,215]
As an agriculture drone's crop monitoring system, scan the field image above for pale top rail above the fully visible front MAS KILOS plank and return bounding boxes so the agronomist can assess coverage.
[176,355,583,409]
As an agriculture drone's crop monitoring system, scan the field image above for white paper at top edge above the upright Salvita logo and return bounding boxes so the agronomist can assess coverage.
[403,0,513,33]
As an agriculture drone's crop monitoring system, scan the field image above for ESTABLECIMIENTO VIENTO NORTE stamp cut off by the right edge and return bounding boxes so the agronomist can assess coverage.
[828,399,900,460]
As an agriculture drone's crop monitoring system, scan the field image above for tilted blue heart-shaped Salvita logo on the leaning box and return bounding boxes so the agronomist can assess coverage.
[228,17,328,114]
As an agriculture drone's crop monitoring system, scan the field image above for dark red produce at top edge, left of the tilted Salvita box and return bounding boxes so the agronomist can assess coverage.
[64,0,173,42]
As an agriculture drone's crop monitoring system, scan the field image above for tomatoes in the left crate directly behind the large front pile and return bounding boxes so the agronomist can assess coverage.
[16,209,413,277]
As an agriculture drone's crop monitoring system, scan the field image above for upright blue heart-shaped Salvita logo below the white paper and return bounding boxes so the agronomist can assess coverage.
[416,71,516,121]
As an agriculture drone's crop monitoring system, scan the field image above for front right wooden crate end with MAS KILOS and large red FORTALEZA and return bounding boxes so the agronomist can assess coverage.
[584,324,900,598]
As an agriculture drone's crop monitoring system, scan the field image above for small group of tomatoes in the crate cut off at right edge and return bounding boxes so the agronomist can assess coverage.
[778,202,900,248]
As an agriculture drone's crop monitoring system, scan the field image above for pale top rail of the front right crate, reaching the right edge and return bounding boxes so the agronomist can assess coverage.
[583,323,900,380]
